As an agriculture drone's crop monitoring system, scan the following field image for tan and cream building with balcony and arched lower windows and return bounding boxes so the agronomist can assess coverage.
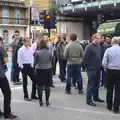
[0,0,29,45]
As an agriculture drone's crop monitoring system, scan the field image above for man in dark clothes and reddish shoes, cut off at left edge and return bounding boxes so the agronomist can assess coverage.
[0,37,17,119]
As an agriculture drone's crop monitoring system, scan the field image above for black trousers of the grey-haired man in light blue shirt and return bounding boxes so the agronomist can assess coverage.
[107,69,120,110]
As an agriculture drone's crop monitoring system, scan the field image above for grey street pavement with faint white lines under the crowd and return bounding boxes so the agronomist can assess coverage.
[0,61,120,120]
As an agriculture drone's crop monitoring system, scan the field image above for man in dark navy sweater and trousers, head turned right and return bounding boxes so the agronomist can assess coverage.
[83,33,104,106]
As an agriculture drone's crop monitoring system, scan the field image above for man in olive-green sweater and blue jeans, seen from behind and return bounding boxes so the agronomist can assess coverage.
[64,33,83,94]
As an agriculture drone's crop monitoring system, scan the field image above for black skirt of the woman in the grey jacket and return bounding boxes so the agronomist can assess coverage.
[35,68,52,86]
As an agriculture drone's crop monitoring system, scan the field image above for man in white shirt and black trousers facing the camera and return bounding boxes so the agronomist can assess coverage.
[17,37,38,101]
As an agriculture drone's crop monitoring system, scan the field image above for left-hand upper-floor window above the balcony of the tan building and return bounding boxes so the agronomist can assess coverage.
[2,7,9,24]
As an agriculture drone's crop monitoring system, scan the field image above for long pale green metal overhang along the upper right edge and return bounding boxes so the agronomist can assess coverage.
[59,0,120,16]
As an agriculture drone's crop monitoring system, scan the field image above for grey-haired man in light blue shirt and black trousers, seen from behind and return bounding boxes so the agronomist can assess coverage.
[102,37,120,113]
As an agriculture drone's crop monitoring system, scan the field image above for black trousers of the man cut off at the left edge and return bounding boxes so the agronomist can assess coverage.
[0,76,11,117]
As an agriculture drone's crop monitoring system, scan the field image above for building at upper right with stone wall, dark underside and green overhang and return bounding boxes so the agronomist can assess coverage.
[57,0,120,40]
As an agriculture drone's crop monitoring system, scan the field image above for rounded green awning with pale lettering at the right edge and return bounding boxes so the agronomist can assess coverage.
[97,21,120,35]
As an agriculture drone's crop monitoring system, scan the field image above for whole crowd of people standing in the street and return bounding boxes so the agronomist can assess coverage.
[0,33,120,119]
